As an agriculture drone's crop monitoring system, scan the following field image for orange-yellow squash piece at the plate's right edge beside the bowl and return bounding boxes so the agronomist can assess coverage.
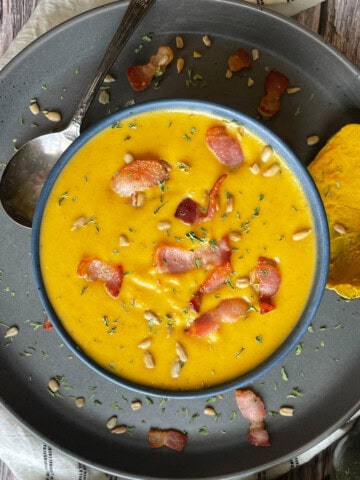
[309,124,360,299]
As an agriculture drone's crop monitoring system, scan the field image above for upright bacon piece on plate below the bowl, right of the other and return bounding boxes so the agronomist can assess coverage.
[235,389,270,447]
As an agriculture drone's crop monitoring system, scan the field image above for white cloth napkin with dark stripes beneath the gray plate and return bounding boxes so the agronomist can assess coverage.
[0,0,344,480]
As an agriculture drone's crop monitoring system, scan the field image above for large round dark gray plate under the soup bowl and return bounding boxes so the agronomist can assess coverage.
[0,0,360,478]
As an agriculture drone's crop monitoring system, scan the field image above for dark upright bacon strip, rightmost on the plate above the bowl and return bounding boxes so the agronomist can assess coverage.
[258,70,289,118]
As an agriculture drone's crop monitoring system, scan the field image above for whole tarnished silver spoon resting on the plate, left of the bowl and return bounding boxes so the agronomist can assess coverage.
[0,0,155,227]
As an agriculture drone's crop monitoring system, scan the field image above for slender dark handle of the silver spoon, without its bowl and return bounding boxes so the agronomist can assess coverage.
[70,0,155,130]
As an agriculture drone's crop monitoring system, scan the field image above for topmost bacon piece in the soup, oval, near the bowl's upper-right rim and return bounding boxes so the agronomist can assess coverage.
[205,126,244,167]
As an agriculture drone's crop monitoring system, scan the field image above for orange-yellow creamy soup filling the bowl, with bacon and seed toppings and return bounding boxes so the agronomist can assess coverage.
[40,111,316,390]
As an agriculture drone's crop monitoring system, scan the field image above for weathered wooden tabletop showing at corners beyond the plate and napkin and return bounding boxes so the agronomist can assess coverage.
[0,0,360,480]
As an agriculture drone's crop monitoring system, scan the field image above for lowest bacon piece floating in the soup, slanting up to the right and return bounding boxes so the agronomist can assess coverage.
[187,298,248,337]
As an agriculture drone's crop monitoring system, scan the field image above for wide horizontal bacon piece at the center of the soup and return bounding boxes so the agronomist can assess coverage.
[154,233,230,273]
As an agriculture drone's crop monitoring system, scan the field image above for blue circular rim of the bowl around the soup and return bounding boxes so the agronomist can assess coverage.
[31,99,330,399]
